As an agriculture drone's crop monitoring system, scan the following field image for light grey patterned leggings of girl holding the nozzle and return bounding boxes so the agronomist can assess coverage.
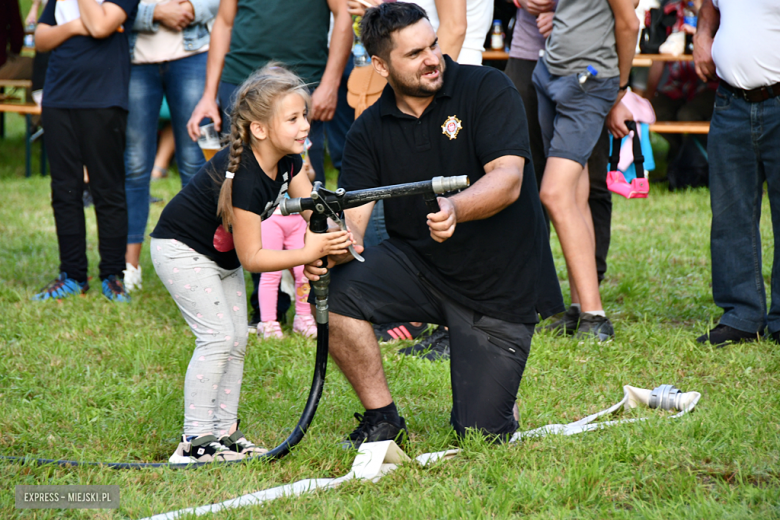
[152,238,247,437]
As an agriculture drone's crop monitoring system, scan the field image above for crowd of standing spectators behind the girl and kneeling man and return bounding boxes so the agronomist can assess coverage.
[0,0,780,356]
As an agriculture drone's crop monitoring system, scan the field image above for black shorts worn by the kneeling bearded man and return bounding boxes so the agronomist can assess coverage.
[329,241,534,440]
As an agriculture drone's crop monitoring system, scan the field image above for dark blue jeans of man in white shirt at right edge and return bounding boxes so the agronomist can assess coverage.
[707,83,780,334]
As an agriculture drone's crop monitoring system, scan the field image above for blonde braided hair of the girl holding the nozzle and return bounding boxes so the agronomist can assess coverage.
[212,62,311,230]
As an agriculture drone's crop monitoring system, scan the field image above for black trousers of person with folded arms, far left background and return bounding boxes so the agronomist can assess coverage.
[43,106,127,282]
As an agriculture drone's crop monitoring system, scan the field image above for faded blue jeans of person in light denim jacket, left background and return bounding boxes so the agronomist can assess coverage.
[125,52,208,244]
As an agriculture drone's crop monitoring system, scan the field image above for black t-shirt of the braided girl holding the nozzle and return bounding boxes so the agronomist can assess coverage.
[152,146,303,269]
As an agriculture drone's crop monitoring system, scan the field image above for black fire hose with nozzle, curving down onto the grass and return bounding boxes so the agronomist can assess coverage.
[0,175,469,469]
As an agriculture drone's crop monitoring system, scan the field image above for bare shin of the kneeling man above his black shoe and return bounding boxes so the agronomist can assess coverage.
[329,312,393,410]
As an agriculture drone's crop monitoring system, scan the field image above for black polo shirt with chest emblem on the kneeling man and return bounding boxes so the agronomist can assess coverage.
[340,56,564,323]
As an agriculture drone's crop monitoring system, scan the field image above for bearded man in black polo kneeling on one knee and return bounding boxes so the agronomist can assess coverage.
[307,2,564,447]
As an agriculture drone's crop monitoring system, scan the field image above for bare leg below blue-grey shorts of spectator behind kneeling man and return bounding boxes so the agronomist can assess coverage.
[540,157,602,311]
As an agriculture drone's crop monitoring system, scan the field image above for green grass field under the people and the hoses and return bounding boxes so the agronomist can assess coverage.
[0,111,780,520]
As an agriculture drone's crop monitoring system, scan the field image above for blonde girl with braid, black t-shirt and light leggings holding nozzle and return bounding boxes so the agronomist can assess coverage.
[151,64,351,463]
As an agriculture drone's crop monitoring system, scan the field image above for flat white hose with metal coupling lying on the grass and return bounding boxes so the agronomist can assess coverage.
[142,385,701,520]
